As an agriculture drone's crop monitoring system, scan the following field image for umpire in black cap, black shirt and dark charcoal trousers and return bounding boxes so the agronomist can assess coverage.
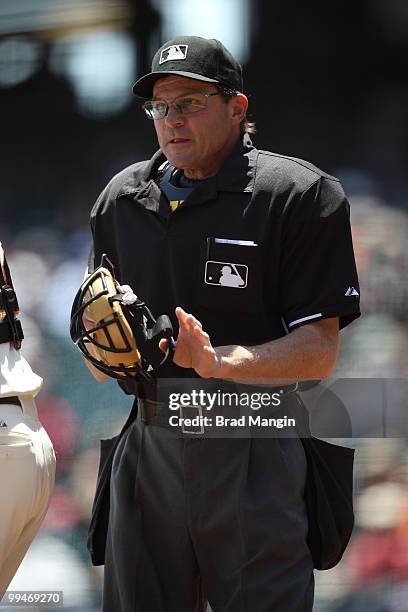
[83,36,359,612]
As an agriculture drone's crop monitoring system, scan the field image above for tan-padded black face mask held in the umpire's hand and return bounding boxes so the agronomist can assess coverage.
[70,255,174,380]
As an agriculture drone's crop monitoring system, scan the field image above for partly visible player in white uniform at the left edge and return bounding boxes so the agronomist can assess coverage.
[0,243,55,600]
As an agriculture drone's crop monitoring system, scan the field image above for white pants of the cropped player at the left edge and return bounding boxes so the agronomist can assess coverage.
[0,396,55,600]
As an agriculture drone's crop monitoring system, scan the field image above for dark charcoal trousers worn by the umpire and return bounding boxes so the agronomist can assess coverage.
[103,418,313,612]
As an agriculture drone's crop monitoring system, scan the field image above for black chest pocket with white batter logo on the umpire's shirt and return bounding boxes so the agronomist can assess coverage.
[196,236,261,314]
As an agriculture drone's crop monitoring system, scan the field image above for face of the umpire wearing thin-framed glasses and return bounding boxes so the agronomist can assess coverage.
[153,76,248,179]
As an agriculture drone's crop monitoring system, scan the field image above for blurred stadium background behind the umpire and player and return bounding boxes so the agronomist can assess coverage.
[0,0,408,612]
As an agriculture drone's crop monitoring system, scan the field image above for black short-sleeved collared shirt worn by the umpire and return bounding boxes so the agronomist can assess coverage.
[91,135,360,378]
